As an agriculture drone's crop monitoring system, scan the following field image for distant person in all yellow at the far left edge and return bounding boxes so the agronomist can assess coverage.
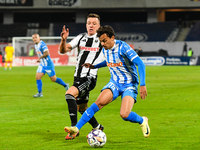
[5,43,14,70]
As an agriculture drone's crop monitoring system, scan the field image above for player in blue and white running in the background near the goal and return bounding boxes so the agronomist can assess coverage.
[32,34,69,98]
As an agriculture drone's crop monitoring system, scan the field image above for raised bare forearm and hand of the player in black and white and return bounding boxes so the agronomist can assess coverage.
[59,25,72,54]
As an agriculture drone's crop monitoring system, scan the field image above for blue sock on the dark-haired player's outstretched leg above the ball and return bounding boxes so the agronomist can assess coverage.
[76,103,99,130]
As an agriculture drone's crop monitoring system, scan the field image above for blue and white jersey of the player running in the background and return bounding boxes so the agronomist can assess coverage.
[35,40,53,66]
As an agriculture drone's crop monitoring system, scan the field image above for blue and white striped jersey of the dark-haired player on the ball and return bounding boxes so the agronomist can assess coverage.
[103,40,139,84]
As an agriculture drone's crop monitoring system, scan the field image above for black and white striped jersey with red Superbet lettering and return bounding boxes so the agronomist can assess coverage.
[69,33,104,78]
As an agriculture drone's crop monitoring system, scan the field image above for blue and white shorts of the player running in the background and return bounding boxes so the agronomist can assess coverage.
[37,65,56,77]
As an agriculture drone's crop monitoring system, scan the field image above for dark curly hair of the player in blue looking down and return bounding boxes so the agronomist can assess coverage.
[97,25,115,38]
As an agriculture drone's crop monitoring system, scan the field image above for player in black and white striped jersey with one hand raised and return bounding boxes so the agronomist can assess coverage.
[59,14,104,140]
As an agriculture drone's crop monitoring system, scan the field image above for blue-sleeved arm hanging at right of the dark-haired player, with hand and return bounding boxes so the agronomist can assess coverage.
[132,56,147,99]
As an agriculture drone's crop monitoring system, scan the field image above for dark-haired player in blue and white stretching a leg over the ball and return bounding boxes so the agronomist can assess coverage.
[65,26,150,137]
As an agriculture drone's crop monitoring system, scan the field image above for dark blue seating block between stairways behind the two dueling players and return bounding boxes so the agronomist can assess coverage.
[53,22,177,41]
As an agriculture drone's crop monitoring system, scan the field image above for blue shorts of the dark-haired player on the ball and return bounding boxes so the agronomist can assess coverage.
[101,79,138,103]
